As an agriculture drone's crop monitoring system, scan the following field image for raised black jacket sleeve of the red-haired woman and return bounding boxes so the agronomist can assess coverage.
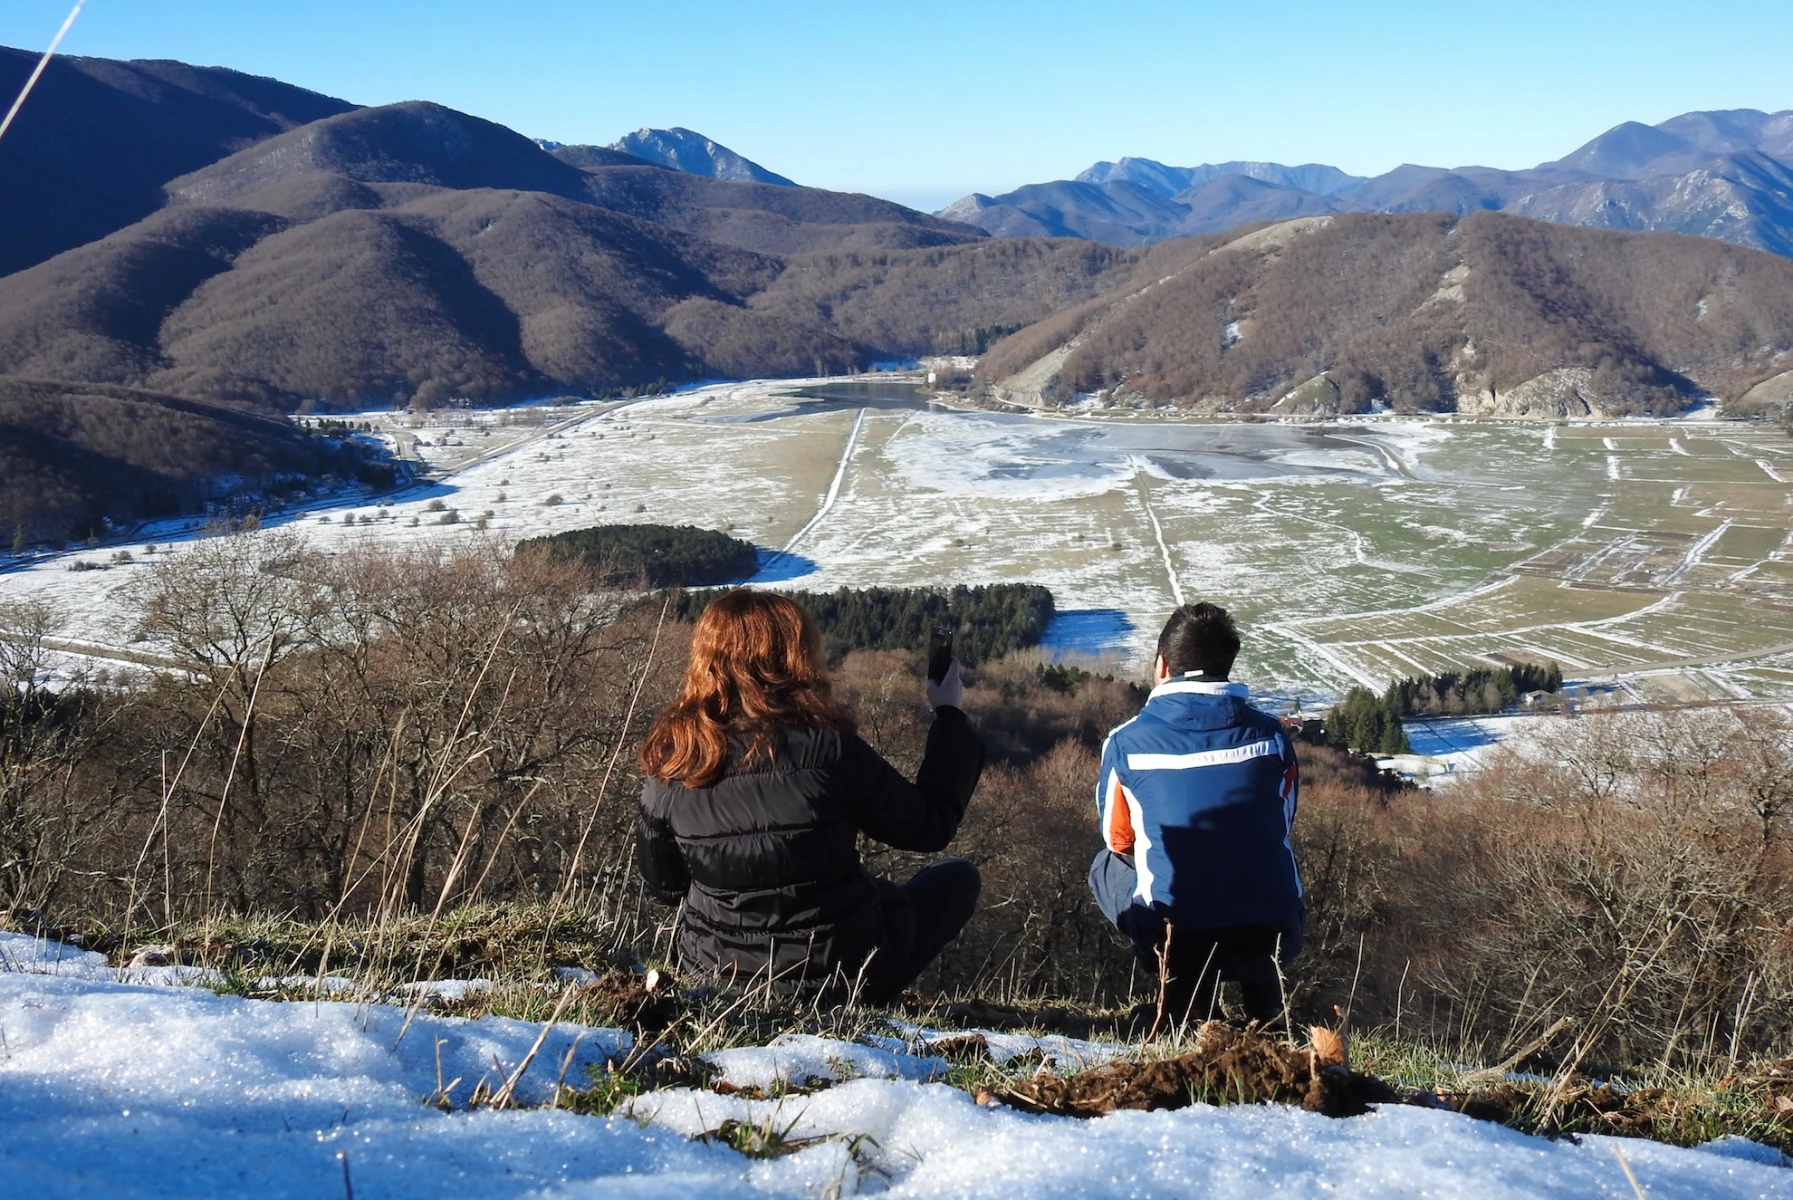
[841,705,984,854]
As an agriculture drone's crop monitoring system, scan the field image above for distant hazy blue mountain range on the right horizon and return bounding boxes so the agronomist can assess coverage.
[938,109,1793,255]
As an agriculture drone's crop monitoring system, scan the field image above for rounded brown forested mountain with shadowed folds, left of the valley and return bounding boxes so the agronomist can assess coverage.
[0,102,1124,409]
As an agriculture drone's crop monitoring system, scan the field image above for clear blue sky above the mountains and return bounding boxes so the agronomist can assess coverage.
[0,0,1793,208]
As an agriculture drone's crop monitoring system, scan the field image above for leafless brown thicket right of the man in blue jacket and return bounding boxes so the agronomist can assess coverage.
[1298,710,1793,1067]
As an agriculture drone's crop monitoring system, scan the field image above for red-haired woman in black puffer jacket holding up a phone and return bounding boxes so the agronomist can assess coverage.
[637,588,984,1004]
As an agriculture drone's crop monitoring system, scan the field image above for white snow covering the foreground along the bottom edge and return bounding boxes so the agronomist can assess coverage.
[0,933,1793,1200]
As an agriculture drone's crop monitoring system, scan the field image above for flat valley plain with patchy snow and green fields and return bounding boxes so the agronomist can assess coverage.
[0,380,1793,707]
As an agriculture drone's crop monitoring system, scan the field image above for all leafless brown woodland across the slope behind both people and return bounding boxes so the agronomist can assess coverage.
[10,531,1793,1078]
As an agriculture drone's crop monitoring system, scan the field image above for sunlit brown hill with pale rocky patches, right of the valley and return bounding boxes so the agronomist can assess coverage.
[981,212,1793,416]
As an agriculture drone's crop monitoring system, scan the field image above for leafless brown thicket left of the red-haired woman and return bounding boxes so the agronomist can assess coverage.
[31,535,678,920]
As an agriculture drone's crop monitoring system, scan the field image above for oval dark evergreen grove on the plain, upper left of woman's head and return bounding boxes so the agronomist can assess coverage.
[516,526,760,588]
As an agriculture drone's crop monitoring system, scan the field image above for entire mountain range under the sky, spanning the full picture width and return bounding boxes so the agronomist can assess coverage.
[0,50,1793,536]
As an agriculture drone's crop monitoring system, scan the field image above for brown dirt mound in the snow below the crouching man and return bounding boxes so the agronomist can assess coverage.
[1002,1021,1400,1117]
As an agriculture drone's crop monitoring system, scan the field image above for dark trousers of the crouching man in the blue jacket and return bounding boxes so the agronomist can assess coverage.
[1090,848,1300,1022]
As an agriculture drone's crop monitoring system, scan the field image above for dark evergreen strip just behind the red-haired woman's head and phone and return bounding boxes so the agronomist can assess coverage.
[678,583,1052,665]
